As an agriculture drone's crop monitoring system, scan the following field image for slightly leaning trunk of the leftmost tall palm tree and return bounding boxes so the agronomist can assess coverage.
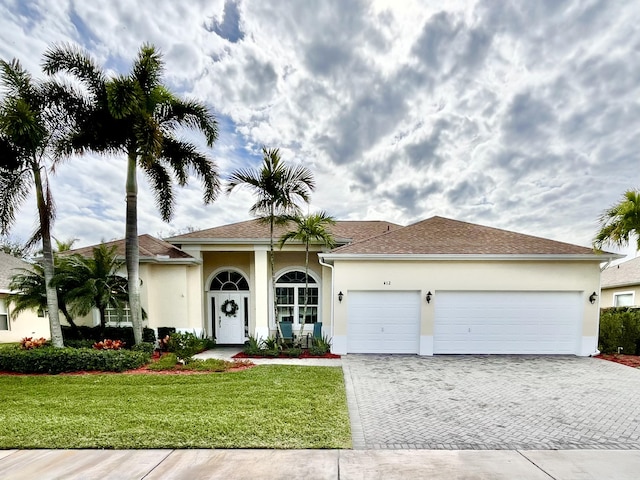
[32,162,64,348]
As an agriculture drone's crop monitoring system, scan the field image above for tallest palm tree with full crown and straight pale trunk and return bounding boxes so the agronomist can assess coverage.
[43,44,220,343]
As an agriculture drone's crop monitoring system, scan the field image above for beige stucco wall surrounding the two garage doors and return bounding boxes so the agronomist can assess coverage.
[334,261,600,337]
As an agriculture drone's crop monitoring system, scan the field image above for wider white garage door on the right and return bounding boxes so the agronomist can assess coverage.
[433,291,582,354]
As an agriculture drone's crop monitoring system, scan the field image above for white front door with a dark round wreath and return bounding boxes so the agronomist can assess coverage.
[209,292,249,345]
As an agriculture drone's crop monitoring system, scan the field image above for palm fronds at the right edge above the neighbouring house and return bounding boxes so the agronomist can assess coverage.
[593,190,640,250]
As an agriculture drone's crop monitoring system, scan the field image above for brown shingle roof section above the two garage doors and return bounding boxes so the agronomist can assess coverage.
[332,217,604,255]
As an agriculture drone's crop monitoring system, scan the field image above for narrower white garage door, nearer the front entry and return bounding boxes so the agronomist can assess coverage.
[347,291,420,353]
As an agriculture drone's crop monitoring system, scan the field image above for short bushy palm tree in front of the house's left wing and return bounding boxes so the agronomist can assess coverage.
[53,245,128,328]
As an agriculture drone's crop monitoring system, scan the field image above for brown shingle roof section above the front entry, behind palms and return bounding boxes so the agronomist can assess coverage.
[169,220,402,244]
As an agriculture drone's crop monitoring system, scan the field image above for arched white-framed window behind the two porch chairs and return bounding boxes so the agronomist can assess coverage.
[276,271,319,325]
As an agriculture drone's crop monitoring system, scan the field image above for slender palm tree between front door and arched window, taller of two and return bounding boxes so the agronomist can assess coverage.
[227,147,315,330]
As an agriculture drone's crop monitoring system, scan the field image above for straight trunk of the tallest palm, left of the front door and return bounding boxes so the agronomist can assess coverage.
[125,146,142,344]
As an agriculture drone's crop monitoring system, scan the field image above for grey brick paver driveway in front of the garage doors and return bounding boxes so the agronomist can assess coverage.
[343,355,640,449]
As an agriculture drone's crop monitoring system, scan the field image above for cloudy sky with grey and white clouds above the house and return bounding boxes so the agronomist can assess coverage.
[0,0,640,258]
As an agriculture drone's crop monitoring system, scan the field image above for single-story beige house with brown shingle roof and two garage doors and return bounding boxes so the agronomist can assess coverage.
[63,217,619,355]
